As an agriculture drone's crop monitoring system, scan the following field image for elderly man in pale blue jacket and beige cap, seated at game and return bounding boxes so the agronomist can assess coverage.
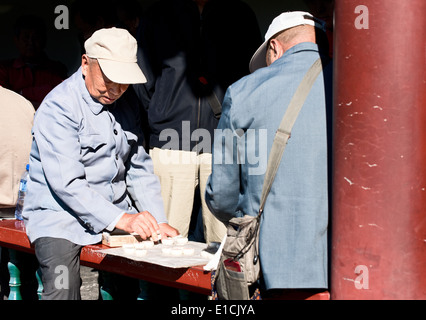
[23,28,178,300]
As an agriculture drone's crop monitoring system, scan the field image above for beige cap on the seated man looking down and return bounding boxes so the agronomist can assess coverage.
[84,28,146,84]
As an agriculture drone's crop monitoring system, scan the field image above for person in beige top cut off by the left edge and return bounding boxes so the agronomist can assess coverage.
[0,86,38,300]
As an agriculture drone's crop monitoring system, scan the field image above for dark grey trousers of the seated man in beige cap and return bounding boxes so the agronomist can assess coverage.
[34,238,82,300]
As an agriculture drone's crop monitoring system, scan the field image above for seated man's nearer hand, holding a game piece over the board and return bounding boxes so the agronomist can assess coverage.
[115,211,160,241]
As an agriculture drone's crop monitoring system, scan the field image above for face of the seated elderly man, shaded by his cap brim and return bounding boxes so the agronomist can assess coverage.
[81,55,129,105]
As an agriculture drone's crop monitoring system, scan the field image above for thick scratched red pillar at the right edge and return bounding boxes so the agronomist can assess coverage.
[331,0,426,299]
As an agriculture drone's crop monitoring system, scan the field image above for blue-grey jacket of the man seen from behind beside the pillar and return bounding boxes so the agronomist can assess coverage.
[206,43,332,289]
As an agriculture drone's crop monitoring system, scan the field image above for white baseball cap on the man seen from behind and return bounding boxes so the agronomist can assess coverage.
[249,11,325,72]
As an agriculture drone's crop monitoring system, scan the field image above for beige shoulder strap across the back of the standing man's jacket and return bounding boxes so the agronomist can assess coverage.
[259,58,322,216]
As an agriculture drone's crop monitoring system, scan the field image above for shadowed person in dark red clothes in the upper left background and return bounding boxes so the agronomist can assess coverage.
[0,15,67,110]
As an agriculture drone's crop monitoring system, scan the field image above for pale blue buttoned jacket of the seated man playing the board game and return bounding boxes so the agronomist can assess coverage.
[23,68,167,245]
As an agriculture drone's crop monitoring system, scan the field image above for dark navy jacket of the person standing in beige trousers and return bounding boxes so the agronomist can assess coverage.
[135,0,262,152]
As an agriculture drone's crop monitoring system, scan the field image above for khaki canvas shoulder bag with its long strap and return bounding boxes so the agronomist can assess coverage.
[214,58,322,300]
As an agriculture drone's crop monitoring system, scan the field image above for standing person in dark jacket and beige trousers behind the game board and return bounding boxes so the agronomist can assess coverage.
[135,0,261,242]
